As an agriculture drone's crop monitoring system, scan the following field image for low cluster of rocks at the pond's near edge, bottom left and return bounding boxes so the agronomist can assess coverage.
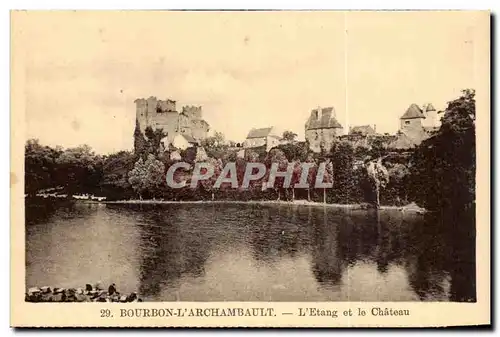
[25,283,142,303]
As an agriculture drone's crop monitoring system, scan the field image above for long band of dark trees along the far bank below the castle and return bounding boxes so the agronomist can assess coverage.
[25,90,475,213]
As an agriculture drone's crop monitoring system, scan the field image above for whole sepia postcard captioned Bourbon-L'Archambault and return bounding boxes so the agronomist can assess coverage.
[11,11,491,328]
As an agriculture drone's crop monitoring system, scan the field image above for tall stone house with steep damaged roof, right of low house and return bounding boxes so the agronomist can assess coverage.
[305,107,343,152]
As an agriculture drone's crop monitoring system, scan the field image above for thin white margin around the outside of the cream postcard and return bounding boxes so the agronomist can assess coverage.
[0,0,500,335]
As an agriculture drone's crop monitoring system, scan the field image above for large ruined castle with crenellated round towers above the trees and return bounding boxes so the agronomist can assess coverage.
[134,96,210,152]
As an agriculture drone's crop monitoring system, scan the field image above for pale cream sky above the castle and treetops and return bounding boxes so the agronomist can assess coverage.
[13,11,478,153]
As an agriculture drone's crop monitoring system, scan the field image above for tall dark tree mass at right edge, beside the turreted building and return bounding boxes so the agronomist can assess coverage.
[410,89,476,212]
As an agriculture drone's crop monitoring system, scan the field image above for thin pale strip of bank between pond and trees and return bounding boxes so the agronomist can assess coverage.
[99,199,427,214]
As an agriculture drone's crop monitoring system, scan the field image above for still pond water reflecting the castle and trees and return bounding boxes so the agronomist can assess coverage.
[26,203,475,301]
